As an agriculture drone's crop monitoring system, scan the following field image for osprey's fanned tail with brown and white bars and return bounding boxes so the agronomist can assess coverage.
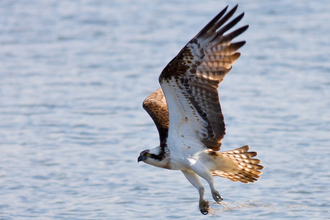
[210,145,264,183]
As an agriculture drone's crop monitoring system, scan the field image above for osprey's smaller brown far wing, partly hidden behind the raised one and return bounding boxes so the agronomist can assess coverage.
[143,88,169,145]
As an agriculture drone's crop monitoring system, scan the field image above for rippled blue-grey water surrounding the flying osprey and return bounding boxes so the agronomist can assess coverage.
[0,0,330,219]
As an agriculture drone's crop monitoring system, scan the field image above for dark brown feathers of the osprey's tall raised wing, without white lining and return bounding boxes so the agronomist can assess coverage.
[159,6,248,150]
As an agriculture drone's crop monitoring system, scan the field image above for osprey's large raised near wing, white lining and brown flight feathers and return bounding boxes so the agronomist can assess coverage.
[159,6,248,150]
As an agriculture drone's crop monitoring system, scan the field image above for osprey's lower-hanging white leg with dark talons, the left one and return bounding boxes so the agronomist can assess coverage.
[182,171,209,215]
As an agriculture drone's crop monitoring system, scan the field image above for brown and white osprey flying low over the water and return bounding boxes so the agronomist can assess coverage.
[138,5,263,215]
